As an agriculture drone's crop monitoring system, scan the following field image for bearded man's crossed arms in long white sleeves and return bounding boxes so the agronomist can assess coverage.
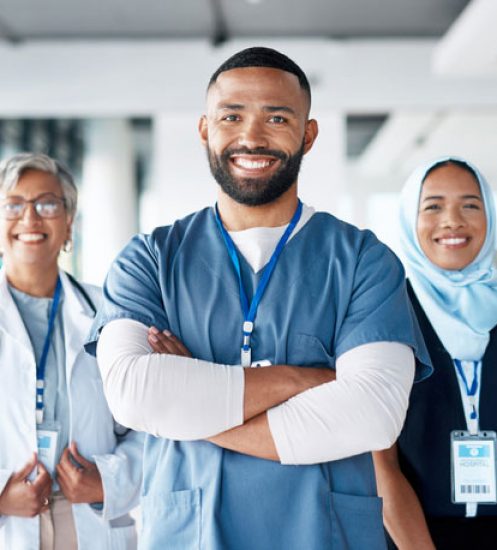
[97,319,414,464]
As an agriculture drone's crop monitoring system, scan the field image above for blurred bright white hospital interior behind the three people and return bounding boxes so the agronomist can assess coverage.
[0,0,497,284]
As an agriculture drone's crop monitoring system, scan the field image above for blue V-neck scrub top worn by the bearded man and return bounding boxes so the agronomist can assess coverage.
[87,208,431,550]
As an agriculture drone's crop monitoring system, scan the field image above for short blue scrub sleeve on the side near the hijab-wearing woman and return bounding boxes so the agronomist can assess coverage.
[335,234,432,381]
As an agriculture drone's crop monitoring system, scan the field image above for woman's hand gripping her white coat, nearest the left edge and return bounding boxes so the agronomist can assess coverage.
[0,453,52,518]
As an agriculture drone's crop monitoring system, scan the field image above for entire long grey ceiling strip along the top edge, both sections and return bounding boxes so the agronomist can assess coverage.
[0,0,468,40]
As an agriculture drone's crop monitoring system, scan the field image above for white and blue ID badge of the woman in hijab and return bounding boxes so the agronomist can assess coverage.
[450,430,497,504]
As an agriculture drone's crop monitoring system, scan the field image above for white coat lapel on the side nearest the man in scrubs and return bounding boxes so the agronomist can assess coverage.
[60,271,93,383]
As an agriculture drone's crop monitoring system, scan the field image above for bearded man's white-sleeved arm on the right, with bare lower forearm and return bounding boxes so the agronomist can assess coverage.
[210,343,414,464]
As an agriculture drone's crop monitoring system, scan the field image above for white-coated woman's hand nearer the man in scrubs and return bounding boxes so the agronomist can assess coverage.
[56,441,104,504]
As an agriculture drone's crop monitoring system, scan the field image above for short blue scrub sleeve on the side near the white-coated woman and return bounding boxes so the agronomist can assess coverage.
[85,235,169,355]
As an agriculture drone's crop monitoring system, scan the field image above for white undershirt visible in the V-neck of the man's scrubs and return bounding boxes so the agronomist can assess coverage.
[229,204,315,273]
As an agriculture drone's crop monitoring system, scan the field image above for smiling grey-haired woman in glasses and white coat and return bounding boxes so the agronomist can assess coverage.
[0,153,142,550]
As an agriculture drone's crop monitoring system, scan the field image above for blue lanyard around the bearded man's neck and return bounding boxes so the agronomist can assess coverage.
[216,200,302,367]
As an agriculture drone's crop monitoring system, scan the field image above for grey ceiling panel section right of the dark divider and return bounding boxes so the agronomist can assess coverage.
[222,0,468,38]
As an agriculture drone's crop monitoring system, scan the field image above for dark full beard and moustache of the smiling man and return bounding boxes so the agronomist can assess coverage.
[207,142,304,206]
